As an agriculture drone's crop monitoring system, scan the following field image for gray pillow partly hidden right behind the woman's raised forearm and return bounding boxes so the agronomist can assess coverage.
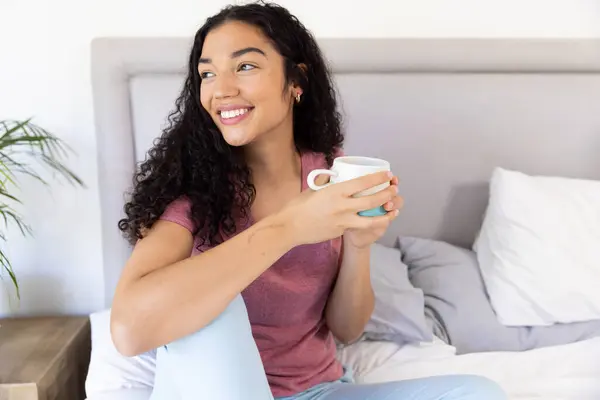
[362,243,433,343]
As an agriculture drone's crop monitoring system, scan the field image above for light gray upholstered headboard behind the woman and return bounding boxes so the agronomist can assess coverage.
[92,38,600,304]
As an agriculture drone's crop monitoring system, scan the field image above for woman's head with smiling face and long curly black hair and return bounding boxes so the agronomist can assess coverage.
[119,4,343,250]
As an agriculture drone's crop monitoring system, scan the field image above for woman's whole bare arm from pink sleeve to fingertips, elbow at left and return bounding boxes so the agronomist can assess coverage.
[111,173,396,355]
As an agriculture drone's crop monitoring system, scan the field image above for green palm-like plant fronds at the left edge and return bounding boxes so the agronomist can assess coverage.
[0,118,84,299]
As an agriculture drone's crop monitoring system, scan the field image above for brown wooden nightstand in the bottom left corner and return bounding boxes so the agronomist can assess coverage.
[0,316,91,400]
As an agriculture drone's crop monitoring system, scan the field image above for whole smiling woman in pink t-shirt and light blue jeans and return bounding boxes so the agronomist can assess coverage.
[111,0,505,400]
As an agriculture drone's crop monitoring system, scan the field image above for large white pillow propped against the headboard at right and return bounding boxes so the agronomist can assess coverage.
[473,168,600,326]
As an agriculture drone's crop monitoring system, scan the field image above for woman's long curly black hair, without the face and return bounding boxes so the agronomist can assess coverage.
[119,3,344,245]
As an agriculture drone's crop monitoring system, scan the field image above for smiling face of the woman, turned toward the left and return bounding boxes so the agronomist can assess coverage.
[198,22,299,146]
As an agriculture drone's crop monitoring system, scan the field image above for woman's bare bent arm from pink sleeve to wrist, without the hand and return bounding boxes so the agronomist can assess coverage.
[111,217,293,356]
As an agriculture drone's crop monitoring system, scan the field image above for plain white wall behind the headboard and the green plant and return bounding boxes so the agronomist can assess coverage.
[0,0,600,315]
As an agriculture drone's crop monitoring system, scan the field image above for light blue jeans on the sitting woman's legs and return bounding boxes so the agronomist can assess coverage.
[150,295,507,400]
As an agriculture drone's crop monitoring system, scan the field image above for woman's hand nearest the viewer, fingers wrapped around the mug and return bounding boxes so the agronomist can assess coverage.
[277,172,397,246]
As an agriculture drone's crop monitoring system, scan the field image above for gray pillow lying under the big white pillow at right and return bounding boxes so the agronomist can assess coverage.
[398,237,600,354]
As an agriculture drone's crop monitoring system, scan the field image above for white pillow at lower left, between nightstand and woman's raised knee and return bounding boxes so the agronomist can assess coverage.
[85,310,156,400]
